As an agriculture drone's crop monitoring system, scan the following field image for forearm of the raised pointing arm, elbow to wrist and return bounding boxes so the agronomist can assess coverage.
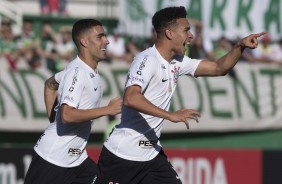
[216,42,245,75]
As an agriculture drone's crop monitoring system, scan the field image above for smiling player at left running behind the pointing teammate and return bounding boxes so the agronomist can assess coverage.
[25,19,122,184]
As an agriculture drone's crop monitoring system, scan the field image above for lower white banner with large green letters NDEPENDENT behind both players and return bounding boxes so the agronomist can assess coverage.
[0,59,282,132]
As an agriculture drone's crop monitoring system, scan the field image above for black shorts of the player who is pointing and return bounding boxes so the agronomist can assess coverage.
[98,147,182,184]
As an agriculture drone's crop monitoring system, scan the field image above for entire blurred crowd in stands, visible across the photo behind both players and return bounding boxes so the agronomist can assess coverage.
[0,19,282,73]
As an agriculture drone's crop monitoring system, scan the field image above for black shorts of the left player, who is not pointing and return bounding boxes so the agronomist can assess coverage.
[24,153,100,184]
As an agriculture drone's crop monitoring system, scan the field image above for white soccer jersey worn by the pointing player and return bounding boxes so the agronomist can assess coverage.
[104,46,200,161]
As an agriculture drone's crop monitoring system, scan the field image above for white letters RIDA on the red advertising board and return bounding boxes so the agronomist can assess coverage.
[170,157,228,184]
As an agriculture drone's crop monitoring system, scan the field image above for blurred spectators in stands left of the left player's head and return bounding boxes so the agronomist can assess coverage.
[0,19,76,73]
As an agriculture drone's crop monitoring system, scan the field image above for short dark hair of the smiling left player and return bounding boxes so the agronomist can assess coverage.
[72,19,103,48]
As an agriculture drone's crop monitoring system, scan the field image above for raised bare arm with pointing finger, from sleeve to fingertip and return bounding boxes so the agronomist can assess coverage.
[195,32,266,77]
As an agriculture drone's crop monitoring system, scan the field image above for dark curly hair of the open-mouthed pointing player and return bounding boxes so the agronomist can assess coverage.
[152,6,187,33]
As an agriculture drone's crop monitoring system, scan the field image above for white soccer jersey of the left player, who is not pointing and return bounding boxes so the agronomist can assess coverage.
[34,57,103,167]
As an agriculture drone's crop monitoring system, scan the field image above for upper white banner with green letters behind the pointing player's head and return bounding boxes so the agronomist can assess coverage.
[119,0,282,40]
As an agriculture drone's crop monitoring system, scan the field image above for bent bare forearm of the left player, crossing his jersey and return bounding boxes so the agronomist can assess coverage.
[61,105,110,124]
